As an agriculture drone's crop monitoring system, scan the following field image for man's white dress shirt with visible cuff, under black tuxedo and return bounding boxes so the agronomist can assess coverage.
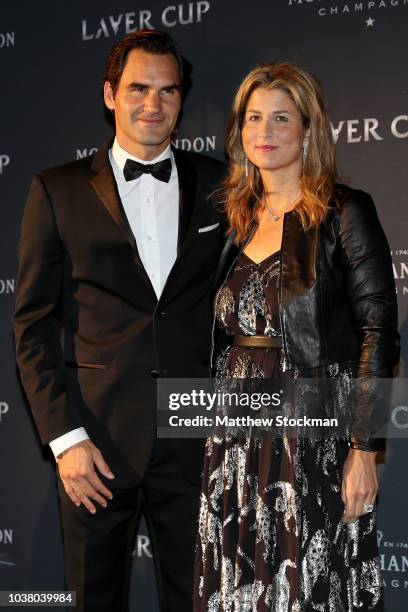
[50,138,179,458]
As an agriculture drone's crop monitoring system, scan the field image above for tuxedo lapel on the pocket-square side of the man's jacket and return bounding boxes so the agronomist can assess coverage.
[173,148,197,257]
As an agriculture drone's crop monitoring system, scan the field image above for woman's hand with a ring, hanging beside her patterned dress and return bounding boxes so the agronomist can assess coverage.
[341,448,378,523]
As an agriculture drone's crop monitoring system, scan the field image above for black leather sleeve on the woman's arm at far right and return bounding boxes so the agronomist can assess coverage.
[339,191,399,450]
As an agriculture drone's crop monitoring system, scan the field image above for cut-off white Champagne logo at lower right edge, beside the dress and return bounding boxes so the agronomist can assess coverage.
[377,529,408,589]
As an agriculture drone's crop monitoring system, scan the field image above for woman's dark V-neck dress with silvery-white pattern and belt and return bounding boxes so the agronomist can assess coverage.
[193,252,383,612]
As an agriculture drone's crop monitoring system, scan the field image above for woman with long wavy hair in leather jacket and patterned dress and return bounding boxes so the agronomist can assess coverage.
[194,63,399,612]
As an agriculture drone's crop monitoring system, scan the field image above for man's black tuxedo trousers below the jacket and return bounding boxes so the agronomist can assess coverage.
[58,440,200,612]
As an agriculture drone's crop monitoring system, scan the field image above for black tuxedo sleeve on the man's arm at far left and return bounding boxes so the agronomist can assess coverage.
[14,176,81,444]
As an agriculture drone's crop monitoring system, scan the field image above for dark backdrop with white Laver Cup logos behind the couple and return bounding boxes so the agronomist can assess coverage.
[0,0,408,612]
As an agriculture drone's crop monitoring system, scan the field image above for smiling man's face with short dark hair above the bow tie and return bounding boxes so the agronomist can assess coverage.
[104,49,181,160]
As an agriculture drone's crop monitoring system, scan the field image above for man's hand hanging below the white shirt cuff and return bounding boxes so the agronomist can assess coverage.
[57,440,115,514]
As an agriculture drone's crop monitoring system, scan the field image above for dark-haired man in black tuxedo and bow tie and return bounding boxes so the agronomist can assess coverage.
[15,30,224,612]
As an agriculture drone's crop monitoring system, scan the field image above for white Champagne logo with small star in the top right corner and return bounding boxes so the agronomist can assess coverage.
[286,0,408,28]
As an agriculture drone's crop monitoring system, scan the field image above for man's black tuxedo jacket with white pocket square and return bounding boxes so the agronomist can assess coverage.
[15,145,224,481]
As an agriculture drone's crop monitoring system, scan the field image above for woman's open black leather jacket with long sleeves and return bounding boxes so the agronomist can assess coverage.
[212,185,399,451]
